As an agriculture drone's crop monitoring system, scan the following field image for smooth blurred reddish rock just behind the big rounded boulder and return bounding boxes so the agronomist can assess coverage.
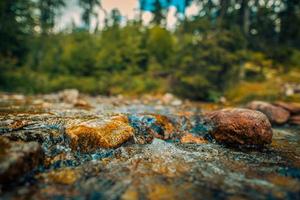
[246,101,290,124]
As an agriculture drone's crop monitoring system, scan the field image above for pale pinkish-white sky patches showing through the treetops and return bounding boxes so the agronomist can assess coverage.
[56,0,202,30]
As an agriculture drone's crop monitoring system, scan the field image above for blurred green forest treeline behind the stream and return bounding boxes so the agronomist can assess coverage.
[0,0,300,100]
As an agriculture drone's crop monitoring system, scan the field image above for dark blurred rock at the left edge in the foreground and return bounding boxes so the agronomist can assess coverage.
[0,137,44,184]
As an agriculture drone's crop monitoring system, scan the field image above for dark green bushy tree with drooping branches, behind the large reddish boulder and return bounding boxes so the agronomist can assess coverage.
[173,26,243,100]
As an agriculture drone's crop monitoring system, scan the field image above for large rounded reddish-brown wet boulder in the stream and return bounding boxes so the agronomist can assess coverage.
[207,108,273,145]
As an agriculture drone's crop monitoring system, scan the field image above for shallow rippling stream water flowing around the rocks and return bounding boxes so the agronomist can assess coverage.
[0,96,300,200]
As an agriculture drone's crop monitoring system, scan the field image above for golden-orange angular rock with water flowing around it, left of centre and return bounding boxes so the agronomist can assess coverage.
[66,116,134,152]
